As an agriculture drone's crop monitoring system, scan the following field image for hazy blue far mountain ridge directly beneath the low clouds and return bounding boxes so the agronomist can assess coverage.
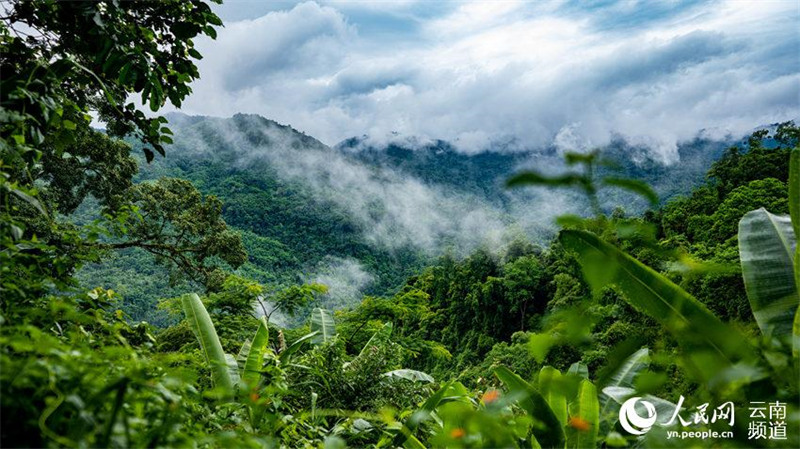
[334,130,737,206]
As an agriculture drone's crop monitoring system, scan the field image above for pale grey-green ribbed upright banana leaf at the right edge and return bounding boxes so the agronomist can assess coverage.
[739,208,800,336]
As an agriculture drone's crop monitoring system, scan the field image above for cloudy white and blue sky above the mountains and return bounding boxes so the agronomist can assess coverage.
[173,0,800,161]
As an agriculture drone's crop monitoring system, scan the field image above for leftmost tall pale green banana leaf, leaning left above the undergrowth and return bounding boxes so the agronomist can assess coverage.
[181,293,234,398]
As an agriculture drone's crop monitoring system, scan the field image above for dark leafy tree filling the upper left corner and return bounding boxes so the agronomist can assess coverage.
[0,0,221,305]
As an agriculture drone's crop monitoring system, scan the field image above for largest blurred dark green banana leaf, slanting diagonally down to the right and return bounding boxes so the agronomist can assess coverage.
[560,230,753,380]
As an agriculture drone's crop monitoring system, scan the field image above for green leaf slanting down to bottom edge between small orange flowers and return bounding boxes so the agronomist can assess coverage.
[494,366,565,448]
